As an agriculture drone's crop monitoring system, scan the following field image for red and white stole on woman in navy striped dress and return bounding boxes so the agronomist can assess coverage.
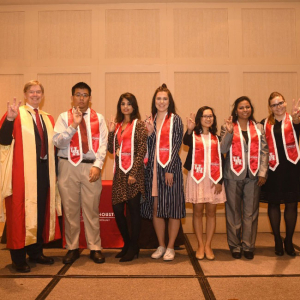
[155,113,174,168]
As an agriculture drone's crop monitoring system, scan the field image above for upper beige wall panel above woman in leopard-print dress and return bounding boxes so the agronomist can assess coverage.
[105,9,160,58]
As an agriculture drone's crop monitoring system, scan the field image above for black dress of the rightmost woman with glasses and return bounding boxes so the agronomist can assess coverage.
[260,120,300,204]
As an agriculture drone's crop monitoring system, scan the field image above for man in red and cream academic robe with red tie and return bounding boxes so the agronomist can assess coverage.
[0,80,60,272]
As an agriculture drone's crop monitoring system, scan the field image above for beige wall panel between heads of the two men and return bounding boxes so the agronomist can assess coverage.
[38,74,91,121]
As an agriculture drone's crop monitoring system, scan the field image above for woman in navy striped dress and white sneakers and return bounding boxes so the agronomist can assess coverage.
[141,84,185,260]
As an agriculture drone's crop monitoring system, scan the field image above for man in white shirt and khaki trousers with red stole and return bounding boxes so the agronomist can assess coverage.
[53,82,107,264]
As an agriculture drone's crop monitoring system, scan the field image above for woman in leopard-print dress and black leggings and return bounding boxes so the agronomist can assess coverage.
[108,93,147,262]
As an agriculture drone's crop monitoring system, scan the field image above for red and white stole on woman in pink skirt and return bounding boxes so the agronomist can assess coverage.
[191,132,222,184]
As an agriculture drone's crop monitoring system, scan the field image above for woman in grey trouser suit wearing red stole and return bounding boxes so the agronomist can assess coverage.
[221,96,269,259]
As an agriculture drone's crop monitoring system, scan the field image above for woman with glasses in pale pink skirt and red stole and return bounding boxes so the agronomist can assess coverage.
[183,106,226,260]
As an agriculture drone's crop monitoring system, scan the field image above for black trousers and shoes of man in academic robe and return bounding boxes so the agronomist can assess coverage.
[10,160,49,264]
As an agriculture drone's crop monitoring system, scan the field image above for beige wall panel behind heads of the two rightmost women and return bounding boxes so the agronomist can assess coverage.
[243,72,298,121]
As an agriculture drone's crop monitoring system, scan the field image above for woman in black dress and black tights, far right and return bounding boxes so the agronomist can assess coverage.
[260,92,300,256]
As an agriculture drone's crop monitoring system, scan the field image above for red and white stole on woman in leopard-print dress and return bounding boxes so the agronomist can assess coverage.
[114,119,137,174]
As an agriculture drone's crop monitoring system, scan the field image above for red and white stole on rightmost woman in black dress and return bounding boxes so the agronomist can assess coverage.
[264,113,300,171]
